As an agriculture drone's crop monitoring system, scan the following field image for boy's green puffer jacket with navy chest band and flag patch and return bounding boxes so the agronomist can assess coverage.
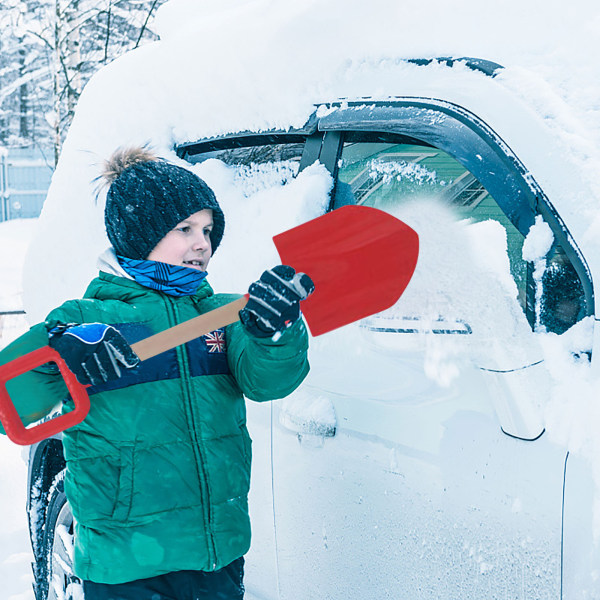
[0,273,308,583]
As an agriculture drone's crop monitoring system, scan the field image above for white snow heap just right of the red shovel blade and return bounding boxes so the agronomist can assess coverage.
[383,204,541,378]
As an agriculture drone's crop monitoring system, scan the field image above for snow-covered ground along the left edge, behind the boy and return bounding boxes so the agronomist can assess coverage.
[0,219,37,600]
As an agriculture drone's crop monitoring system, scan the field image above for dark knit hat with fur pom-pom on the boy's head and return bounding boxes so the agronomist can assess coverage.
[102,148,225,260]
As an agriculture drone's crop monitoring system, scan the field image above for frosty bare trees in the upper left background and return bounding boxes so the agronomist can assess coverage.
[0,0,165,161]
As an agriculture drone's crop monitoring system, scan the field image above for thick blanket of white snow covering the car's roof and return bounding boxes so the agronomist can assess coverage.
[24,0,600,321]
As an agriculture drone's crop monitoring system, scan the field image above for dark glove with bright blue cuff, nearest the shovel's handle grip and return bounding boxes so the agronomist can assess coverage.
[48,323,140,385]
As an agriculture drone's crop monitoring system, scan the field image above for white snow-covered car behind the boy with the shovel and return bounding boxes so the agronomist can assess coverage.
[21,44,600,600]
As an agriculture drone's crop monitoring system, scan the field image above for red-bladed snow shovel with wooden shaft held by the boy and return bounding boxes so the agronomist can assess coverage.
[0,205,419,445]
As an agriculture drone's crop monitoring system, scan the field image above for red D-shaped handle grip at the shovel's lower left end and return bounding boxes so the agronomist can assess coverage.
[0,346,90,446]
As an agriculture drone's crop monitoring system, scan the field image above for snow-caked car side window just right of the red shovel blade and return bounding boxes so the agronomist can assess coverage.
[336,142,530,334]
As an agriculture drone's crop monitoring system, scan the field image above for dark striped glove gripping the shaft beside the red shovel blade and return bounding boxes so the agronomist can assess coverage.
[240,265,315,338]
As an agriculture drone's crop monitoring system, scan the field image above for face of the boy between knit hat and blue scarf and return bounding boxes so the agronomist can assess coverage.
[148,209,213,271]
